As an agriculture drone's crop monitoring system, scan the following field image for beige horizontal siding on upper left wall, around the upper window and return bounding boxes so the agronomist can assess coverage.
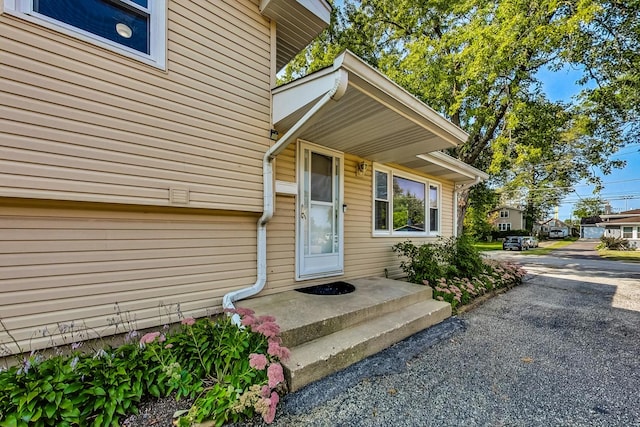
[0,0,271,212]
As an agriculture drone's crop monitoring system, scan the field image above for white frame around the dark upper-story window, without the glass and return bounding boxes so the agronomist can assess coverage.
[4,0,167,70]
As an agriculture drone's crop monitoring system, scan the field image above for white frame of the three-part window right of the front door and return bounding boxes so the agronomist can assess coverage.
[371,163,442,237]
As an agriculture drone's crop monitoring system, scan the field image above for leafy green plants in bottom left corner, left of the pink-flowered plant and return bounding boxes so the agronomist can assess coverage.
[0,345,154,427]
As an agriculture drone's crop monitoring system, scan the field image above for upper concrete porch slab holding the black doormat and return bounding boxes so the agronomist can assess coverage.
[238,277,432,348]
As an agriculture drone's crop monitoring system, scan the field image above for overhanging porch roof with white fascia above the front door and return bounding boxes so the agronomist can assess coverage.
[272,51,476,182]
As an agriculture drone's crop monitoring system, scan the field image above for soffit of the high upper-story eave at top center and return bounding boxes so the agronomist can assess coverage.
[260,0,331,70]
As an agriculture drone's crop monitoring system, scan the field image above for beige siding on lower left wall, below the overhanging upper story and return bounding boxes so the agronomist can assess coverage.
[0,199,257,356]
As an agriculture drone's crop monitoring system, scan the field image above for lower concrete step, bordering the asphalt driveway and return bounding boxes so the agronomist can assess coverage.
[284,299,451,391]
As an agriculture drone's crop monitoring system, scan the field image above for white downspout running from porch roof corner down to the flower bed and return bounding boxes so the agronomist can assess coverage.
[222,69,349,325]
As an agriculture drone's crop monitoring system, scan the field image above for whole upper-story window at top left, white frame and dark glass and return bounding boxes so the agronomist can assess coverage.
[5,0,166,68]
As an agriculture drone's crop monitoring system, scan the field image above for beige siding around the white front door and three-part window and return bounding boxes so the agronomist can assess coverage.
[264,145,454,293]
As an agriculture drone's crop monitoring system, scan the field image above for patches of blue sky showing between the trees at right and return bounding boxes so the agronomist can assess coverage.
[538,69,640,220]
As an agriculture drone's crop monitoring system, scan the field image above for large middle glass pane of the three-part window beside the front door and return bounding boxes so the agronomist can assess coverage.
[393,176,425,231]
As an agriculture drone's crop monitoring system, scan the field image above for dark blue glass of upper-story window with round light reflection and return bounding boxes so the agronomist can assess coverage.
[33,0,150,54]
